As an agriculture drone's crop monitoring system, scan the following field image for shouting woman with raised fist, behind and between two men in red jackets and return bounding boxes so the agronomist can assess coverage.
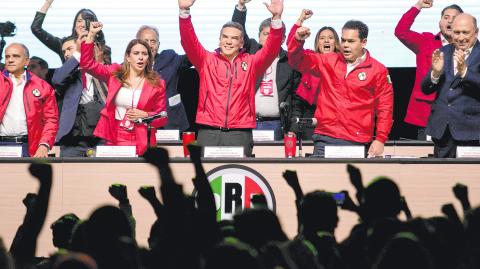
[288,9,340,140]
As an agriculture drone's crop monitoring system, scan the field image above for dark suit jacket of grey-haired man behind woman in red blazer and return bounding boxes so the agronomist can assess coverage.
[153,50,192,132]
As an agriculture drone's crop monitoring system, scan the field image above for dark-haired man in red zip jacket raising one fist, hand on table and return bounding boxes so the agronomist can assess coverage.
[288,20,393,157]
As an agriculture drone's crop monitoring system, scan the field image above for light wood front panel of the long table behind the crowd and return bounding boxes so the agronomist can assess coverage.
[0,158,480,255]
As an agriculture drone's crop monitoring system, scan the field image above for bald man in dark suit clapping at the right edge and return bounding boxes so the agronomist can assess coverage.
[422,14,480,158]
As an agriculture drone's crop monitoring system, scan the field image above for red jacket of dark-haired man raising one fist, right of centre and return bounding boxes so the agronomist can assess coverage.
[288,38,393,143]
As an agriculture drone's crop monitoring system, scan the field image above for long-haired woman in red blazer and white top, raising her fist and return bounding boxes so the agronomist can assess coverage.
[80,22,167,155]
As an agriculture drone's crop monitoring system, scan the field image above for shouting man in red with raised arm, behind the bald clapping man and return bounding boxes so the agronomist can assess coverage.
[395,0,463,140]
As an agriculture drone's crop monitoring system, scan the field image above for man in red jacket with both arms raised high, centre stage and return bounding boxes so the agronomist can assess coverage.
[178,0,283,156]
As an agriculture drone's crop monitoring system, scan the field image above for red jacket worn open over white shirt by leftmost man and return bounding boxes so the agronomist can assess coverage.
[0,71,58,156]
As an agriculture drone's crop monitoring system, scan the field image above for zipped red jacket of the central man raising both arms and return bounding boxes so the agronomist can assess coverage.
[180,16,283,128]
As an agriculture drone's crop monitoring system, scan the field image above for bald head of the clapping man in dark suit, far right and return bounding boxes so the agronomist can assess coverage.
[452,13,478,51]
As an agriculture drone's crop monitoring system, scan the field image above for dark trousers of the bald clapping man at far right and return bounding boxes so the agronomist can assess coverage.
[432,126,480,158]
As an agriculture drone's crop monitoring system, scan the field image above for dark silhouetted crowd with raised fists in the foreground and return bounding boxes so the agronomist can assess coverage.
[0,145,480,269]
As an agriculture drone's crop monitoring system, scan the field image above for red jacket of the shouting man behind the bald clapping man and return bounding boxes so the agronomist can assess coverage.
[395,7,442,127]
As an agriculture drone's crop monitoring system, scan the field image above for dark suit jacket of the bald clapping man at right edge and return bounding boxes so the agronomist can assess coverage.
[422,41,480,141]
